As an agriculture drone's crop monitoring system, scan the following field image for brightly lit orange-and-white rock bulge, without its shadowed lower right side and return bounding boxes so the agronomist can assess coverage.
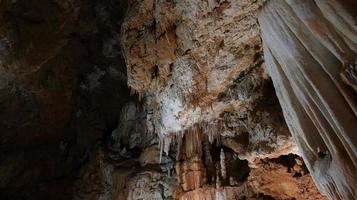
[122,0,261,141]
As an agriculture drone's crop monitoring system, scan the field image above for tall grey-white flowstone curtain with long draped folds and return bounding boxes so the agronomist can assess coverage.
[259,0,357,199]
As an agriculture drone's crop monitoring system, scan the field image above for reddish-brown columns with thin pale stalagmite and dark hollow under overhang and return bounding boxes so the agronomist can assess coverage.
[176,124,249,199]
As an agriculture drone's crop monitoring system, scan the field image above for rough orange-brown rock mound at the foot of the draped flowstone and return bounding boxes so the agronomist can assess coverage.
[248,154,327,200]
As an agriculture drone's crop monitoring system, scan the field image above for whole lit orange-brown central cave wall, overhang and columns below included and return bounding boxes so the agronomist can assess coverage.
[121,0,325,200]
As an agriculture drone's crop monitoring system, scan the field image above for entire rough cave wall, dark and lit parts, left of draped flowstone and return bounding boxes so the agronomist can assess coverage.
[0,0,344,200]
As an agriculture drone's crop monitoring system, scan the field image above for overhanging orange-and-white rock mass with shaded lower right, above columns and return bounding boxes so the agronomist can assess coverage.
[122,0,296,166]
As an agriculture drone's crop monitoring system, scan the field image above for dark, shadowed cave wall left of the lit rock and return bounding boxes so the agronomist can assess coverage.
[0,0,134,200]
